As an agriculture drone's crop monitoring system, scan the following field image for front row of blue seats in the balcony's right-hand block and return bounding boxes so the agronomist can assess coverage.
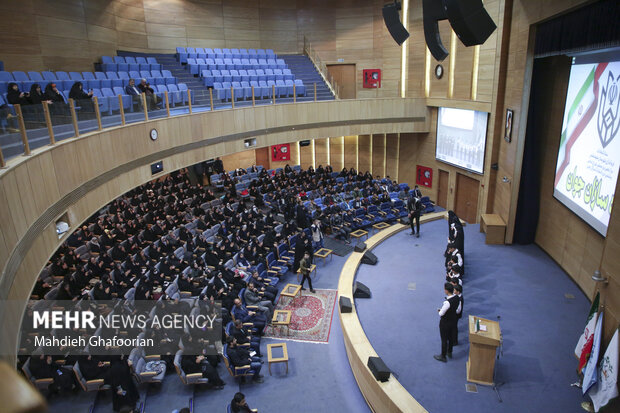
[213,79,306,100]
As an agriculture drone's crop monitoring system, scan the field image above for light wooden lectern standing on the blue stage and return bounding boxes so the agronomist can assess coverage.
[467,315,501,386]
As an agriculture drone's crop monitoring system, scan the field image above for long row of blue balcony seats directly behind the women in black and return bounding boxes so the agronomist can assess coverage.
[0,70,177,91]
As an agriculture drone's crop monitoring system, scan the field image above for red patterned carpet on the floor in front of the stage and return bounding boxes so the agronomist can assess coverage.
[265,290,338,343]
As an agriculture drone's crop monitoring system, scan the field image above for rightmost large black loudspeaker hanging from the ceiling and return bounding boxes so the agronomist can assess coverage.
[443,0,497,46]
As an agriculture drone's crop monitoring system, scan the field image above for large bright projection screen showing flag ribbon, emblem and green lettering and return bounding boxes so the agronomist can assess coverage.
[554,62,620,235]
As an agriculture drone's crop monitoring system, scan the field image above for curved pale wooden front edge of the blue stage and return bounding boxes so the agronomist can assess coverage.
[338,212,446,413]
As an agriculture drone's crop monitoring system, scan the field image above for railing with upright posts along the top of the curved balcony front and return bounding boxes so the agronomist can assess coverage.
[0,83,326,168]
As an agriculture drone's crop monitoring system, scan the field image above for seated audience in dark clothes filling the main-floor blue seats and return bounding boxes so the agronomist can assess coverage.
[21,160,432,406]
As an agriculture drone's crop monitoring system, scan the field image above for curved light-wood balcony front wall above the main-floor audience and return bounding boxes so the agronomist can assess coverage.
[0,98,429,360]
